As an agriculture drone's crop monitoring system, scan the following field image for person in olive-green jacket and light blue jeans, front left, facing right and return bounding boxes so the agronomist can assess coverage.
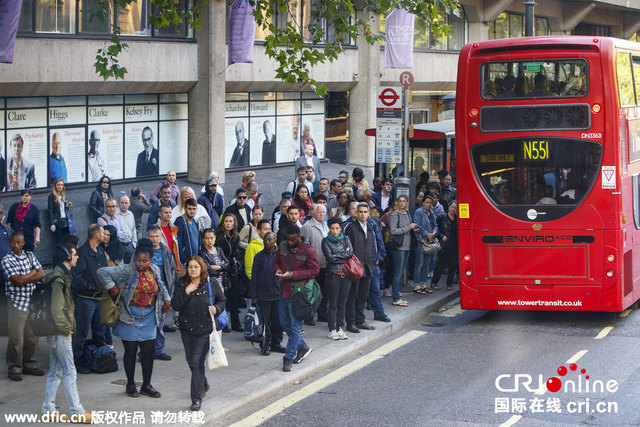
[42,245,91,424]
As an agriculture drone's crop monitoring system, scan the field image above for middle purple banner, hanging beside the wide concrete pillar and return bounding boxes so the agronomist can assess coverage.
[229,0,256,65]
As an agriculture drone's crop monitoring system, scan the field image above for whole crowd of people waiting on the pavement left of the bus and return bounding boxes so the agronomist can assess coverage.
[0,153,458,420]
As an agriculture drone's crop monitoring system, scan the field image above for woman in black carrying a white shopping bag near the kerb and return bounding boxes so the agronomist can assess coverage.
[171,256,226,411]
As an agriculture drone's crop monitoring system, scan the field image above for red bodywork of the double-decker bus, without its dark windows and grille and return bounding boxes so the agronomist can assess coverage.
[456,36,640,311]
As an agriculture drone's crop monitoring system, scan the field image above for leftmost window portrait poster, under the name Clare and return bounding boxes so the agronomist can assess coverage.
[7,128,48,190]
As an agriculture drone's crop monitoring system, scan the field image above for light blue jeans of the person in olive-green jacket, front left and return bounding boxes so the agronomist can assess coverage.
[42,335,84,415]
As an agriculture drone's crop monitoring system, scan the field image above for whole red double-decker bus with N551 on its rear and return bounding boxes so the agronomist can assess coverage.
[456,36,640,311]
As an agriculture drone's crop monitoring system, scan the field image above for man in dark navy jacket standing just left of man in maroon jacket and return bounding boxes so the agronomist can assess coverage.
[251,232,285,356]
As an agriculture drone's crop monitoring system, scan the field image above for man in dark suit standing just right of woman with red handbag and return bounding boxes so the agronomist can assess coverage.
[344,203,376,334]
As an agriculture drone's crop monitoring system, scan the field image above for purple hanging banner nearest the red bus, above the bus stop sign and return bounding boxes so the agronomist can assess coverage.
[384,9,415,68]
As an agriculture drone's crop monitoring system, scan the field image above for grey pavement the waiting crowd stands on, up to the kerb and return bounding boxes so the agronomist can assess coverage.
[0,285,459,425]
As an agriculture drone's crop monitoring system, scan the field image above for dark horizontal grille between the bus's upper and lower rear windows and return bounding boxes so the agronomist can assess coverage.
[480,104,591,132]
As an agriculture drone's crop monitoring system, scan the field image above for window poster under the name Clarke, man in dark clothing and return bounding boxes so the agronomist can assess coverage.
[87,123,124,182]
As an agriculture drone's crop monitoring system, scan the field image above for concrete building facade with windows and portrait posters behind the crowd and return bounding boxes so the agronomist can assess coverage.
[0,0,640,191]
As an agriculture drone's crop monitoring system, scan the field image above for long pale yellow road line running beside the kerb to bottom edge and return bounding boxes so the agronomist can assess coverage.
[231,331,427,427]
